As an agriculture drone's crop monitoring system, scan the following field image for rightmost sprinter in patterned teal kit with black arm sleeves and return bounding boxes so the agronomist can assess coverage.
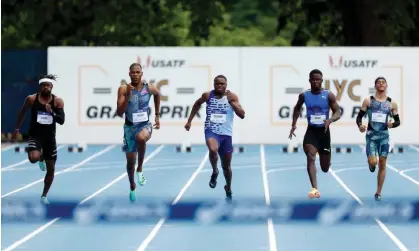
[356,77,400,200]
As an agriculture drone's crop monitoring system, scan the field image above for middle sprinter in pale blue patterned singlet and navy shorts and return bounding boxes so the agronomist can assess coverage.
[185,75,245,201]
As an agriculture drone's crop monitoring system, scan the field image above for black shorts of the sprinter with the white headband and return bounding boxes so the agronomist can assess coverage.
[28,136,57,160]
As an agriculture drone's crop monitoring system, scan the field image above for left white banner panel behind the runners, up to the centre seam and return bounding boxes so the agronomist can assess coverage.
[48,47,240,143]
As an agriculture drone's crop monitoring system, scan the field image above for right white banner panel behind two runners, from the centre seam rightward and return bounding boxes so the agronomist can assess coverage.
[241,47,419,144]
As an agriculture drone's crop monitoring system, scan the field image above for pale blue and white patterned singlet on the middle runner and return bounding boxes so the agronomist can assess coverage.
[205,91,234,136]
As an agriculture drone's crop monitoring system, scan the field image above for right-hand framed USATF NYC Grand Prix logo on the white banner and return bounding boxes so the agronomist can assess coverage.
[270,56,403,126]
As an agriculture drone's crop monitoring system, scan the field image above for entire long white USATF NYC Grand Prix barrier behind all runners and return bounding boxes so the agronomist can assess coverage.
[48,47,419,144]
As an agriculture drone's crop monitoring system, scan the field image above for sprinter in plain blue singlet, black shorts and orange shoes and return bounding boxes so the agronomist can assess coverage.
[289,69,340,198]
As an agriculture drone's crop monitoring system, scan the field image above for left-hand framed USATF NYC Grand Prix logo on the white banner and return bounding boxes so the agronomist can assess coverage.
[79,55,211,126]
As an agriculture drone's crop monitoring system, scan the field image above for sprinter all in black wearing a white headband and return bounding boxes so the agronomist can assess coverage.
[13,75,65,204]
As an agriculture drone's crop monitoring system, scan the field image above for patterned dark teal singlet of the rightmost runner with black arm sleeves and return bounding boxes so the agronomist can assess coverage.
[367,96,391,136]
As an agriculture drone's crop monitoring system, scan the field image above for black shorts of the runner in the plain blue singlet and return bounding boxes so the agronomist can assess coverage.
[303,127,331,154]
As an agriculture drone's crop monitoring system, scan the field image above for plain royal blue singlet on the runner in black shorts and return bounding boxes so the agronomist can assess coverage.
[304,89,330,127]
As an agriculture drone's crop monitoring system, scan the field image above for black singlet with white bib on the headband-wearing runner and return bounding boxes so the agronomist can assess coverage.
[28,94,56,137]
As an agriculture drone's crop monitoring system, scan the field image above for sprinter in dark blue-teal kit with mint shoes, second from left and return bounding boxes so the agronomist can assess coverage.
[117,63,160,201]
